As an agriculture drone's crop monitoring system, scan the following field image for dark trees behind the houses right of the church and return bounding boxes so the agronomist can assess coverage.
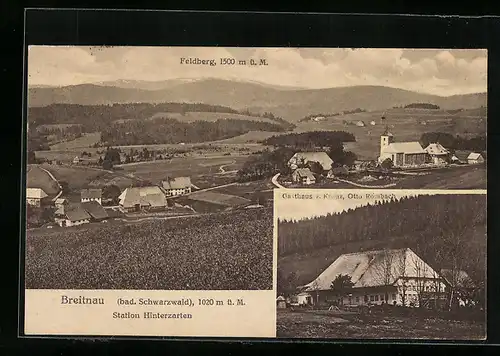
[420,132,486,152]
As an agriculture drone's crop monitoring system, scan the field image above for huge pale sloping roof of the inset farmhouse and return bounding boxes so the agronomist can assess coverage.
[304,248,437,291]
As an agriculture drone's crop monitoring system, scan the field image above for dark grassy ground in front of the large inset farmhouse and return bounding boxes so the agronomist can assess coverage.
[277,310,486,340]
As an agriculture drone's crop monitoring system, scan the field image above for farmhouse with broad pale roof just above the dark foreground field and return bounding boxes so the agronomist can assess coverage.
[118,186,167,212]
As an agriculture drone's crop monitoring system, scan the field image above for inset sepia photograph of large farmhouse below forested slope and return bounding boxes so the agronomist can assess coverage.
[275,189,487,340]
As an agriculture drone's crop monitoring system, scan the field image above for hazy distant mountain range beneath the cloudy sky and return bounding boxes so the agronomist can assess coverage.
[28,79,487,122]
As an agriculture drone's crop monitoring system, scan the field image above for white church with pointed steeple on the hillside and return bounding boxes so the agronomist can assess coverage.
[379,130,427,167]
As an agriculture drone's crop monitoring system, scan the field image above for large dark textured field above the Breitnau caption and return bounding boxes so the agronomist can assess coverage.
[26,209,273,290]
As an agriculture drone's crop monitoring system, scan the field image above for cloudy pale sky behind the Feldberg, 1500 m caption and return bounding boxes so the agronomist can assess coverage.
[28,46,487,96]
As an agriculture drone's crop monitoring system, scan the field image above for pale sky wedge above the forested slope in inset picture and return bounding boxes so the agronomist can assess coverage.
[275,189,426,220]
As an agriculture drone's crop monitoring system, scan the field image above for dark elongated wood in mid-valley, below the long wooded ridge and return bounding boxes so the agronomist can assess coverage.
[101,118,286,146]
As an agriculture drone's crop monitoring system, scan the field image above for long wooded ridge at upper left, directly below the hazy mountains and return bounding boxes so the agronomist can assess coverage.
[28,103,294,132]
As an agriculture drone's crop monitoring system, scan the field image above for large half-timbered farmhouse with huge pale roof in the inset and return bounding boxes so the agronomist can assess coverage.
[299,248,446,306]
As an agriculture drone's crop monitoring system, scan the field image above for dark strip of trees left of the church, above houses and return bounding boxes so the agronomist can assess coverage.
[263,131,356,148]
